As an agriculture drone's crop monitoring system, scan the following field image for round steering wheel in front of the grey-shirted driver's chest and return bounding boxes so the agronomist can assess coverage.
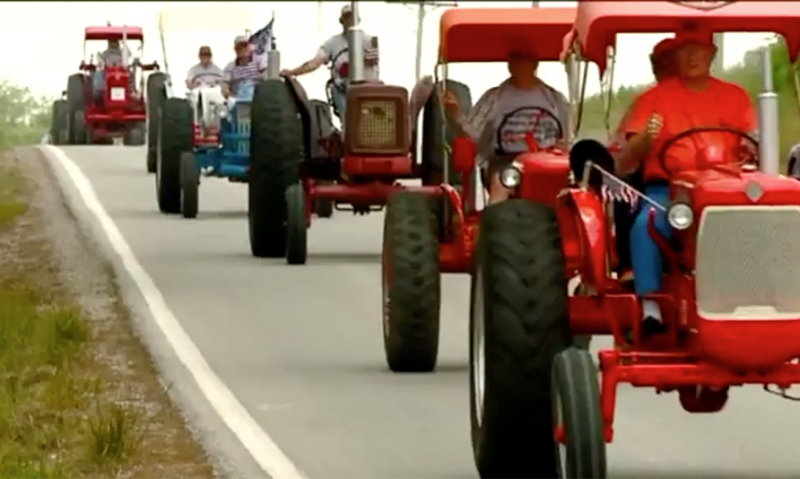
[497,106,563,153]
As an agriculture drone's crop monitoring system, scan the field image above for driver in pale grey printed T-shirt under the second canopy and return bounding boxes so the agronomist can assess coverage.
[444,52,570,204]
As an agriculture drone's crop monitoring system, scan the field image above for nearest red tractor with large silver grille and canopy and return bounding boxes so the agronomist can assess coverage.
[453,1,800,478]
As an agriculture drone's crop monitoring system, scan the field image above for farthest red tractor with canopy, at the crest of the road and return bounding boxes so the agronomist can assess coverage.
[67,25,159,145]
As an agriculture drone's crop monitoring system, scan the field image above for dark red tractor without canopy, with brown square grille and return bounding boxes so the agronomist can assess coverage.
[248,2,450,264]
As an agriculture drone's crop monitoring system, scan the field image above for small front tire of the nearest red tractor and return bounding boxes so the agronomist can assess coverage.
[551,348,608,479]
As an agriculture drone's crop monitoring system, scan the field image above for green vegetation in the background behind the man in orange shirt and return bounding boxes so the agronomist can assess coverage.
[581,40,800,165]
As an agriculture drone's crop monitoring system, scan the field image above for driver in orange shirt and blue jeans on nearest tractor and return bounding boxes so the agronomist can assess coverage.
[616,33,756,332]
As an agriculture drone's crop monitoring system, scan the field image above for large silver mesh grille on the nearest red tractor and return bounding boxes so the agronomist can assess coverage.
[695,206,800,320]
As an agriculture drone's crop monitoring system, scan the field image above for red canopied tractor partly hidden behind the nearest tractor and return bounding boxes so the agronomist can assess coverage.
[382,8,575,372]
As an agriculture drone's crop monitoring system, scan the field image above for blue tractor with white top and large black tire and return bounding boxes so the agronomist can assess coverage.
[156,83,255,218]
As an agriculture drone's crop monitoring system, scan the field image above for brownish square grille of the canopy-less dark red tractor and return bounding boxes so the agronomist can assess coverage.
[356,99,400,149]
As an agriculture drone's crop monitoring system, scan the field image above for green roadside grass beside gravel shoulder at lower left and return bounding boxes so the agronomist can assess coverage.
[0,168,139,479]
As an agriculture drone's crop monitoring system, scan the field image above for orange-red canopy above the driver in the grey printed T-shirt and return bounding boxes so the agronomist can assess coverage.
[439,7,576,63]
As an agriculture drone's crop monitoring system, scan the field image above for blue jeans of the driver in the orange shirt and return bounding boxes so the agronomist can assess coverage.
[631,185,672,296]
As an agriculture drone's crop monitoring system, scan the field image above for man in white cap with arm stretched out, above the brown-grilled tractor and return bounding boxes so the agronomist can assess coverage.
[281,4,380,127]
